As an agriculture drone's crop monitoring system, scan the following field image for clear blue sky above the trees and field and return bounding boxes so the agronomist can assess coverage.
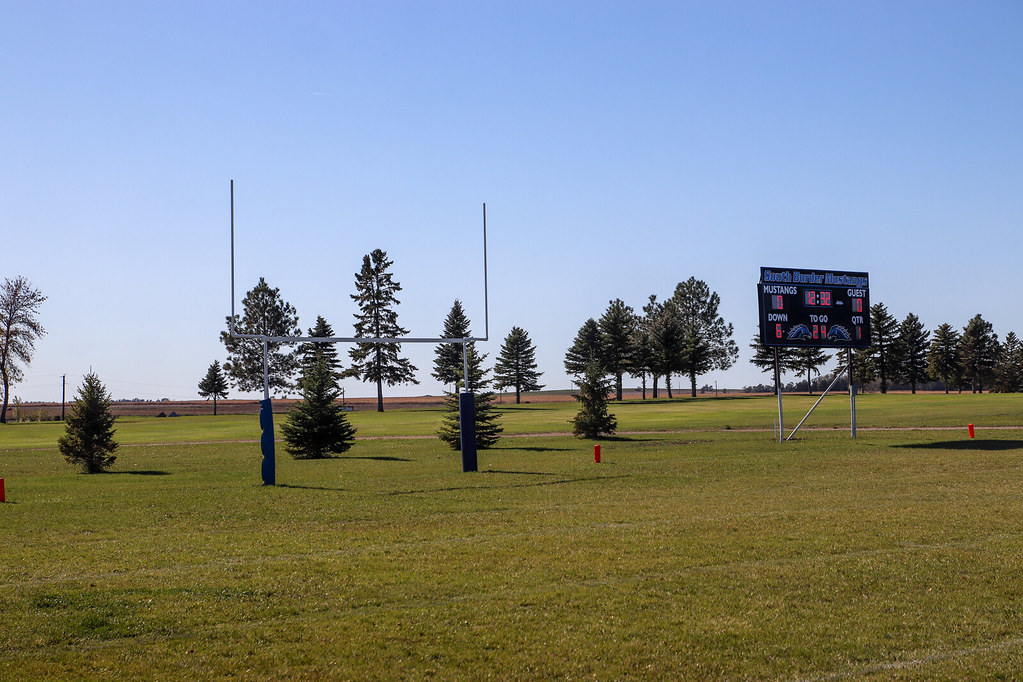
[0,0,1023,401]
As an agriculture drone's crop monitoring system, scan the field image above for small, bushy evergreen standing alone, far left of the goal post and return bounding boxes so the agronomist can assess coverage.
[57,372,118,473]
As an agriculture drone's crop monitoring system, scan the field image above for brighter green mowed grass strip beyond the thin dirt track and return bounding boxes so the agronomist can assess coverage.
[0,394,1023,450]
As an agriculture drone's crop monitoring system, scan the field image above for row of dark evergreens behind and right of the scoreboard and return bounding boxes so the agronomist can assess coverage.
[750,303,1023,393]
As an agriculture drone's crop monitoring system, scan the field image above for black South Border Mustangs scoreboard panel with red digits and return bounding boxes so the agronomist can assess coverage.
[757,268,871,348]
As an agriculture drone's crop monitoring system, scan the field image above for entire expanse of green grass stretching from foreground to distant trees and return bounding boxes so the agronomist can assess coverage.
[0,395,1023,680]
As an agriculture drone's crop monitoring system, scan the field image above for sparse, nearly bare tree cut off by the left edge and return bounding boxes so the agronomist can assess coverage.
[0,276,46,423]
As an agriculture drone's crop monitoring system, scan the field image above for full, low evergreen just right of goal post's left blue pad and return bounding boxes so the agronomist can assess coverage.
[280,357,355,459]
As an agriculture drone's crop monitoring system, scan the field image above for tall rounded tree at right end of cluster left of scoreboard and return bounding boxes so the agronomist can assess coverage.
[671,277,739,398]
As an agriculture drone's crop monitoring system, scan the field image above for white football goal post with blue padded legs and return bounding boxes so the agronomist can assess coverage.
[228,184,490,486]
